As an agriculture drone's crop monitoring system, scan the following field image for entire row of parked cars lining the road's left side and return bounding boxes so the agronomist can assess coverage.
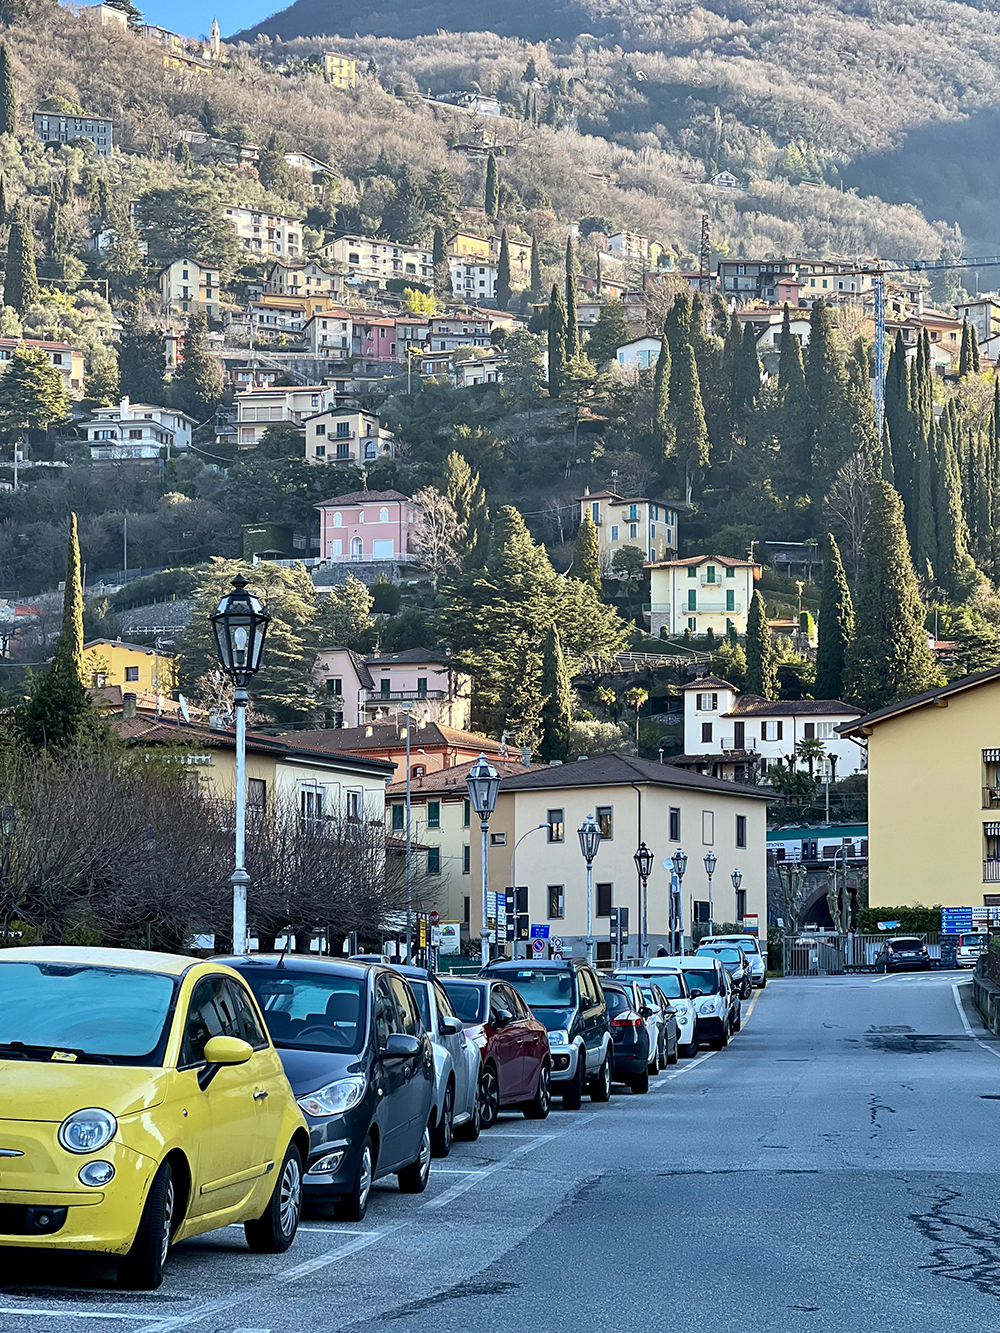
[0,937,767,1289]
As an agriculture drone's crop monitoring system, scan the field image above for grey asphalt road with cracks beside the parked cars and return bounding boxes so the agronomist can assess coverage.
[0,973,1000,1333]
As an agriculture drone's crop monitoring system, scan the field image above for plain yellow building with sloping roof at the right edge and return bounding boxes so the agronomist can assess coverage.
[840,668,1000,908]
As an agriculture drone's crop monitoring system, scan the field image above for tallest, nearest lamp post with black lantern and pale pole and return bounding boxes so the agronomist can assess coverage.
[209,575,271,954]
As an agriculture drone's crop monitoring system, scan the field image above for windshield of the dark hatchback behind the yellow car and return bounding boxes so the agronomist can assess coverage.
[243,968,365,1054]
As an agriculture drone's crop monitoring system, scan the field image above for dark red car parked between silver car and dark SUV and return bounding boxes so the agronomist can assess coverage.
[439,977,552,1129]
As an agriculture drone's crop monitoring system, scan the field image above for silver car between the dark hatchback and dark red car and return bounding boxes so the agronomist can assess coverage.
[393,965,483,1157]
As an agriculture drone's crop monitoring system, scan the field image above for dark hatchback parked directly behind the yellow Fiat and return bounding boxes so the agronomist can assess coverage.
[221,954,435,1222]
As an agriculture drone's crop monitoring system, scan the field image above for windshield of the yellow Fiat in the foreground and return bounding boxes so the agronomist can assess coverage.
[0,962,176,1065]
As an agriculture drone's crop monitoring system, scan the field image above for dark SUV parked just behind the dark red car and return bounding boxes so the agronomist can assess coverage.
[483,958,613,1110]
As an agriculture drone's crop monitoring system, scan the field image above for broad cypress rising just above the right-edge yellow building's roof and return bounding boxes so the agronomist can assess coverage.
[845,481,937,710]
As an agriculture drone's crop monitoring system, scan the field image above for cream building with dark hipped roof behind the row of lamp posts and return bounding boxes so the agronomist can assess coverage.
[471,753,768,961]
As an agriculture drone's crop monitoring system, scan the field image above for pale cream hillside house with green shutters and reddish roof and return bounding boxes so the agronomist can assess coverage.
[649,556,761,637]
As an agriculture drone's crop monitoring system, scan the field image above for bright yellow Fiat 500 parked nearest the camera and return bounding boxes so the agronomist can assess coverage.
[0,948,309,1289]
